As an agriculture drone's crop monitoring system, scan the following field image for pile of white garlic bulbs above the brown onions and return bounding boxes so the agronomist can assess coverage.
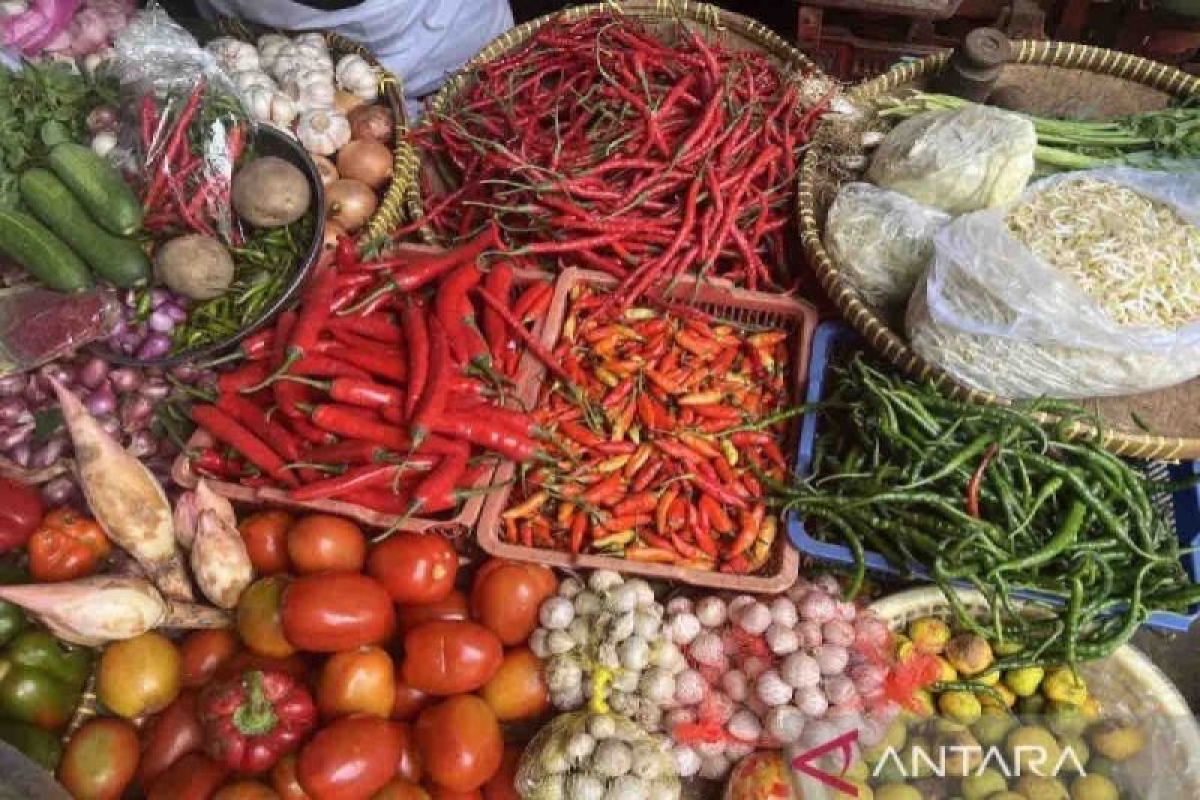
[205,34,380,156]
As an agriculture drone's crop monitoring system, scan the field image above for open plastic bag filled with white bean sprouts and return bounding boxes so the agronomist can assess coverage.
[906,163,1200,398]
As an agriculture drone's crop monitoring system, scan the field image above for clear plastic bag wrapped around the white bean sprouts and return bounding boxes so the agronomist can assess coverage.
[906,168,1200,398]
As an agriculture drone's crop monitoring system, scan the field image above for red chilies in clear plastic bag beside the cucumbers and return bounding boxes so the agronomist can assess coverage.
[138,80,246,245]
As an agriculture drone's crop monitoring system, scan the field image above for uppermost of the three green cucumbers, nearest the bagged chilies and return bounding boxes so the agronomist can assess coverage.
[47,142,143,236]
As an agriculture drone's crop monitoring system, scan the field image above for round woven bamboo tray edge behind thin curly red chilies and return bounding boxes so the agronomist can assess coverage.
[421,0,821,242]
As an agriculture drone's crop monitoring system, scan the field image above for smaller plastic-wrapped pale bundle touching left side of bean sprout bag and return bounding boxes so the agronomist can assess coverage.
[824,182,950,309]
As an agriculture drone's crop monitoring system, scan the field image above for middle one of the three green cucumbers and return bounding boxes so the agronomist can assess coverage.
[18,169,150,288]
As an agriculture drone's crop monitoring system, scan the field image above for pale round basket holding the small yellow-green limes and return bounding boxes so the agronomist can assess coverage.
[870,587,1200,800]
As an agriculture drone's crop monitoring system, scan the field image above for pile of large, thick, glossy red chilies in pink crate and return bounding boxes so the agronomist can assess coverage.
[191,227,552,516]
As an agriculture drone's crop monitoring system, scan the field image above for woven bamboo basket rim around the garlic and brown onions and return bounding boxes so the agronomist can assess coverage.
[214,17,421,241]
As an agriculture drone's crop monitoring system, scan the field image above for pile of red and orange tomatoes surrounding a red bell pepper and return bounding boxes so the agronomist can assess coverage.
[59,511,558,800]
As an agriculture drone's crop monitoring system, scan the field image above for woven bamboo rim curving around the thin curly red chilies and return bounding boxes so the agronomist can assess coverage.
[412,0,824,242]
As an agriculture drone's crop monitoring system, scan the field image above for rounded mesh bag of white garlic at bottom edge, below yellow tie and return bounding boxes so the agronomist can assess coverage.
[515,711,680,800]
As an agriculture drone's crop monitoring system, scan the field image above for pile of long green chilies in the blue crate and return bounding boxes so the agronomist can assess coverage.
[774,355,1200,668]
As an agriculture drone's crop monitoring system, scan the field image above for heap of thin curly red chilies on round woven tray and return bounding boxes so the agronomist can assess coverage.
[413,13,830,302]
